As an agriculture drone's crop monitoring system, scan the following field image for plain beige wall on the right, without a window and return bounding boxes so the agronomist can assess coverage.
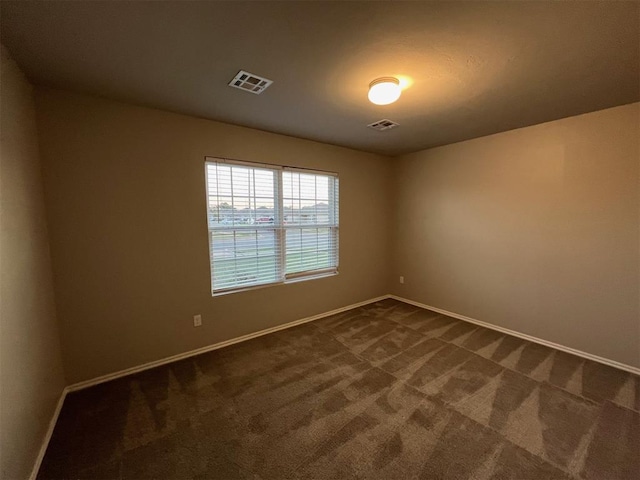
[393,103,640,367]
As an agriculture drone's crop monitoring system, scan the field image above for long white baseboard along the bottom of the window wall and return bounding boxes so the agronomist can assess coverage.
[67,295,389,392]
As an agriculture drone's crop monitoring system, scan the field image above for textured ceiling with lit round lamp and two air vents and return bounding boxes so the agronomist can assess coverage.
[0,1,640,155]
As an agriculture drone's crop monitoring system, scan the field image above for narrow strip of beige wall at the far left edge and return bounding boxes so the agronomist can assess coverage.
[0,47,65,479]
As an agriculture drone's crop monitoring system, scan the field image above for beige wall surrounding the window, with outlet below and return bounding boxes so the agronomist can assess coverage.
[37,90,391,383]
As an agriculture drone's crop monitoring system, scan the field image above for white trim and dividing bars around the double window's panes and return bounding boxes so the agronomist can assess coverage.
[204,156,340,297]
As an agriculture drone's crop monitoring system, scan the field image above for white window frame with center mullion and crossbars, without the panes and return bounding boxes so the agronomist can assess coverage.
[204,156,340,297]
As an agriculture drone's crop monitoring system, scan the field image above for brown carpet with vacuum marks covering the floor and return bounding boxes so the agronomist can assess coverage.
[38,300,640,480]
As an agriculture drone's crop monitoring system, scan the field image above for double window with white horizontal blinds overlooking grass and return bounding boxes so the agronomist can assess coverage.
[205,158,338,294]
